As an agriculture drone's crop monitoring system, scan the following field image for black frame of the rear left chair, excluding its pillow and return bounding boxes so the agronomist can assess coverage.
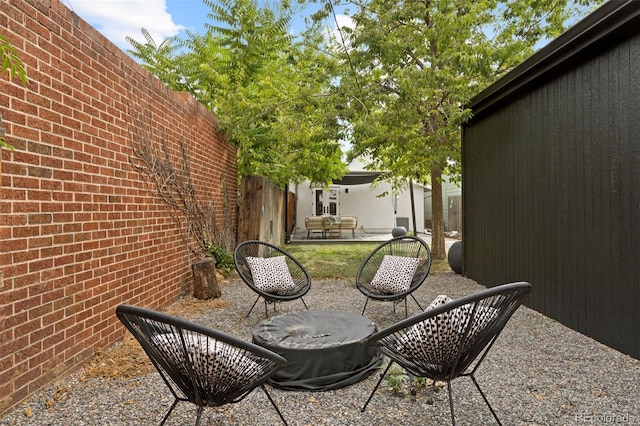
[233,240,311,317]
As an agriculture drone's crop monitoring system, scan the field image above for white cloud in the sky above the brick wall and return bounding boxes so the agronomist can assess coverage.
[65,0,184,50]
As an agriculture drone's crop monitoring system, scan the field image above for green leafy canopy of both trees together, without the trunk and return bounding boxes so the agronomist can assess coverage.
[124,0,600,190]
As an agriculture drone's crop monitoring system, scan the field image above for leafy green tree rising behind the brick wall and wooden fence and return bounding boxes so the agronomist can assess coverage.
[128,0,346,186]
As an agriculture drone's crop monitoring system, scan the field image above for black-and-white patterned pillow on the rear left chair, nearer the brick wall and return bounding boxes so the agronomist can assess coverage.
[247,256,296,296]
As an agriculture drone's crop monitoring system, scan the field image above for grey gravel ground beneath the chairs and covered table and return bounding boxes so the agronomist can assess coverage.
[0,273,640,426]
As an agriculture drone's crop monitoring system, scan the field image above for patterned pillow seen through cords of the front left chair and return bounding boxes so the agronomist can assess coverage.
[153,333,262,387]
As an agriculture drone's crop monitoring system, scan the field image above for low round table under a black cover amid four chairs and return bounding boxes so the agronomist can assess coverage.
[252,311,382,391]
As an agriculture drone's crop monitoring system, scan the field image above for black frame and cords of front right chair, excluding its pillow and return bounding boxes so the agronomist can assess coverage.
[361,282,532,425]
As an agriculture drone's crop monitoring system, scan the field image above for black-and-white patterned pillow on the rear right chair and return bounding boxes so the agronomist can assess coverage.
[371,254,420,294]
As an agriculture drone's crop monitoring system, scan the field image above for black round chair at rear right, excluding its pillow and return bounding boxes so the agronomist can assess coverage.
[356,236,431,317]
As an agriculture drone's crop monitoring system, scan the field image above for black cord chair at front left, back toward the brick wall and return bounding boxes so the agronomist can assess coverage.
[116,305,287,425]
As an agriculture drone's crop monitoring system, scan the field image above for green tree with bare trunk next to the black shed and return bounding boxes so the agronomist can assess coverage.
[335,0,594,259]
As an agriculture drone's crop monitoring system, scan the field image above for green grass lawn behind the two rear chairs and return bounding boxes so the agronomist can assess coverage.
[284,243,451,281]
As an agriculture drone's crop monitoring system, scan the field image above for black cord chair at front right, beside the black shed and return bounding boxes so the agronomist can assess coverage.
[361,282,531,425]
